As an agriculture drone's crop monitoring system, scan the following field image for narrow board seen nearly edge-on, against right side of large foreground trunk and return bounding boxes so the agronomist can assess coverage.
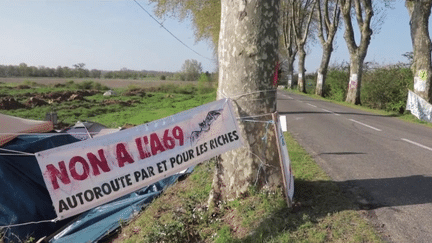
[272,112,294,207]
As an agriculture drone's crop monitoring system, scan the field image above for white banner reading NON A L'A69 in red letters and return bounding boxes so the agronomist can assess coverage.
[36,99,243,219]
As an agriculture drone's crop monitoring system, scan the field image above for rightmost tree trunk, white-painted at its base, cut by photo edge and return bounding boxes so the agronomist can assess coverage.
[406,0,432,102]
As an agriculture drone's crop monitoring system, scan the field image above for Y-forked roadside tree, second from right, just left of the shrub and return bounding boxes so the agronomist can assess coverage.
[341,0,374,104]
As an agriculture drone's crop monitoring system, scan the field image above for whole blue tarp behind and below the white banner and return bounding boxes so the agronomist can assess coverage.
[0,133,192,243]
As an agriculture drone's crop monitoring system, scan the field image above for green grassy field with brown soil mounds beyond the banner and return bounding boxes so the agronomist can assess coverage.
[0,81,216,127]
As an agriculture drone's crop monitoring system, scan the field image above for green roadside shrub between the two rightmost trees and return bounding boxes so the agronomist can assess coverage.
[361,65,413,113]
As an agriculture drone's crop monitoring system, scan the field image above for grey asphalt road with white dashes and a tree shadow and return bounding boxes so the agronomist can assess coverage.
[277,91,432,242]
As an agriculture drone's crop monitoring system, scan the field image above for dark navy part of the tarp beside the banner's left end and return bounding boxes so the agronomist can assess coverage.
[0,134,78,242]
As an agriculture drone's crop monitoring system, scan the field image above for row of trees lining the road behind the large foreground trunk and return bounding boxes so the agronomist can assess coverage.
[150,0,432,104]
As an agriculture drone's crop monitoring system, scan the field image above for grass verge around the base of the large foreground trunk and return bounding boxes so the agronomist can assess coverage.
[106,133,382,242]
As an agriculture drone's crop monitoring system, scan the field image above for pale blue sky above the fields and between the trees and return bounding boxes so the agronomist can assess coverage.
[0,0,426,72]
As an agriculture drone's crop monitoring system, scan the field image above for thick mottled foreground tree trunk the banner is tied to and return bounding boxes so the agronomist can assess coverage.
[210,0,283,205]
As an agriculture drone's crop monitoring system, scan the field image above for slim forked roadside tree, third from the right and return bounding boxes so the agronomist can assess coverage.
[315,0,341,96]
